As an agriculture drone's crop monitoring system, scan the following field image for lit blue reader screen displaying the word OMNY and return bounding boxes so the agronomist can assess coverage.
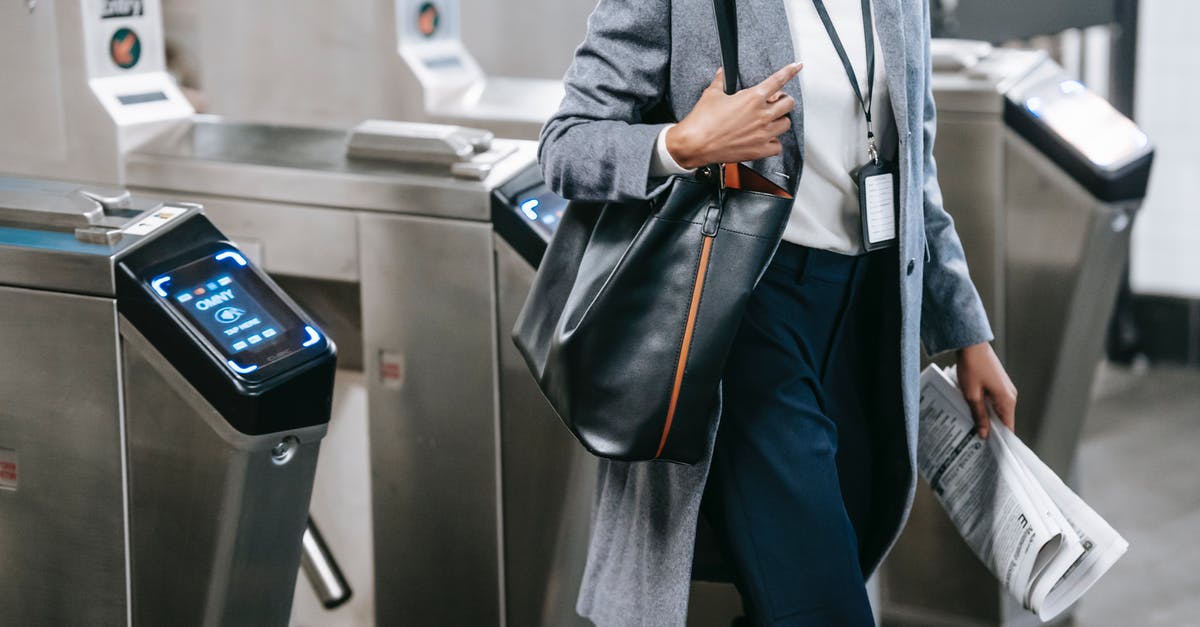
[150,251,317,372]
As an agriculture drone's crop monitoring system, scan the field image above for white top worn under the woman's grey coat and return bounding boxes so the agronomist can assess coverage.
[650,0,895,255]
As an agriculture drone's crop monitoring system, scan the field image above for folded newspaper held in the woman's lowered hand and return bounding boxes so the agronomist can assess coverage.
[917,365,1129,621]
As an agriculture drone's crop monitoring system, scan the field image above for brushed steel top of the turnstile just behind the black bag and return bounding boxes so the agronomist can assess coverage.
[126,117,536,220]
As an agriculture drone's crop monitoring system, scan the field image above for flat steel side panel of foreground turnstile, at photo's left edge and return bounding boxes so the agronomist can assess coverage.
[0,287,128,627]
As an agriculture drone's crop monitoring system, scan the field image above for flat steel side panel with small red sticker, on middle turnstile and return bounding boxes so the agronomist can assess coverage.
[359,215,504,625]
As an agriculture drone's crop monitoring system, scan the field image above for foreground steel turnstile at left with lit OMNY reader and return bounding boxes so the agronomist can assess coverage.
[0,179,335,626]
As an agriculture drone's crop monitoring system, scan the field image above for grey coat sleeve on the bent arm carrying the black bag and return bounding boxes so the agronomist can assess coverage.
[538,0,671,202]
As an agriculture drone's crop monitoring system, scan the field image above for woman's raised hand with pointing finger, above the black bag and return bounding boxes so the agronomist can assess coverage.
[666,62,804,169]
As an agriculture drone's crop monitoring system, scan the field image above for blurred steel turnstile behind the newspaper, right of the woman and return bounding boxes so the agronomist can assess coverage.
[883,41,1153,626]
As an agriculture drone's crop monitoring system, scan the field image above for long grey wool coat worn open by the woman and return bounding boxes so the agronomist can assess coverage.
[539,0,991,627]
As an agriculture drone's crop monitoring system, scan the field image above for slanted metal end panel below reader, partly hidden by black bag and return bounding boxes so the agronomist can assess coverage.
[494,237,596,627]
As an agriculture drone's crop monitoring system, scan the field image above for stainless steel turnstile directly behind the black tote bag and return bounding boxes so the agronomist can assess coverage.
[127,118,595,627]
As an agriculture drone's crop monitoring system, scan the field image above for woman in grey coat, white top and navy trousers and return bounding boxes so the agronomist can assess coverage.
[540,0,1016,627]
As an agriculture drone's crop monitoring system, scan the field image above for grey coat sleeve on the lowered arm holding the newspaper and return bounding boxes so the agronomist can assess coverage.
[920,0,992,354]
